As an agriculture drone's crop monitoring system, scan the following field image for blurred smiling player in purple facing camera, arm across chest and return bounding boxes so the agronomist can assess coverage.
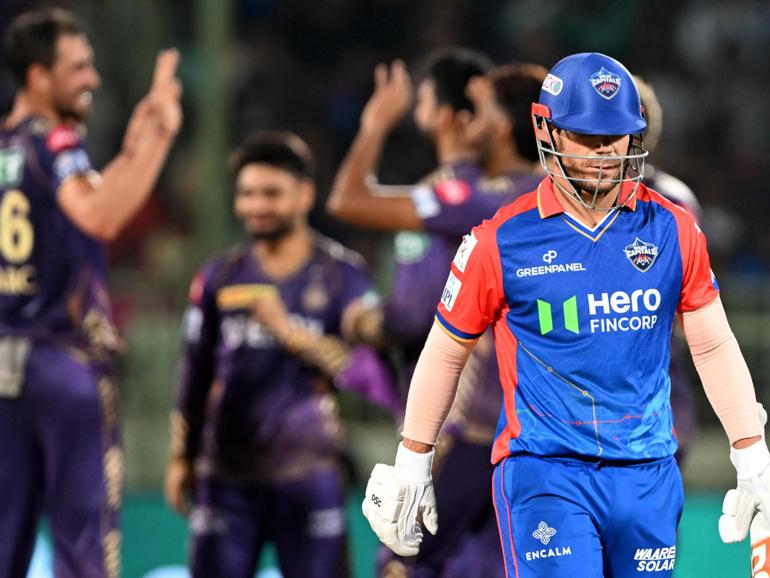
[166,133,396,578]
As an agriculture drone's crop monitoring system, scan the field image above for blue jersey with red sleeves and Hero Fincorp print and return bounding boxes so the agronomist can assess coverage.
[437,178,718,463]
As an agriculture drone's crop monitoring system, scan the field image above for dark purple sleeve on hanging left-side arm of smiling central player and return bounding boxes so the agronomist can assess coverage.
[177,272,219,460]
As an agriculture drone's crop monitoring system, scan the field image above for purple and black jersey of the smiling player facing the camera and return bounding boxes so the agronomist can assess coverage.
[178,236,371,481]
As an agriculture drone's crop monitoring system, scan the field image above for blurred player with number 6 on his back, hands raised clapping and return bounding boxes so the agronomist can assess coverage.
[0,9,182,578]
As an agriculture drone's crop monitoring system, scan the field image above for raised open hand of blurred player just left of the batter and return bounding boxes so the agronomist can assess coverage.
[361,60,412,133]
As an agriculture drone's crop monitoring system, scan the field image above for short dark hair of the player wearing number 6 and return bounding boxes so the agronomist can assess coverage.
[3,8,85,86]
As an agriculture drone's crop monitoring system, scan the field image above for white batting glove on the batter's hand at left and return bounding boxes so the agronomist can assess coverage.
[362,443,438,556]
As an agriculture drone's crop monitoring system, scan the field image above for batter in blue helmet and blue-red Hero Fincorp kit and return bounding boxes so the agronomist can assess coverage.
[363,53,770,578]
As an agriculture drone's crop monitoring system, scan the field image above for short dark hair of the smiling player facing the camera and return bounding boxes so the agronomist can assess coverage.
[230,131,315,180]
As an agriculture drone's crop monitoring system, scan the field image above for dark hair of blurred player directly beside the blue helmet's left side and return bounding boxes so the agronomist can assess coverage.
[491,63,548,162]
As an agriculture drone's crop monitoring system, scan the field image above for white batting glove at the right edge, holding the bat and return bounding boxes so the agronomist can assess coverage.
[719,403,770,544]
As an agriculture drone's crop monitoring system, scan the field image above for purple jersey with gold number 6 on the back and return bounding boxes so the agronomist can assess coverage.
[0,118,117,358]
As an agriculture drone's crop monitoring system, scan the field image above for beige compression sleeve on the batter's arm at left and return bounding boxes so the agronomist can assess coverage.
[403,322,476,445]
